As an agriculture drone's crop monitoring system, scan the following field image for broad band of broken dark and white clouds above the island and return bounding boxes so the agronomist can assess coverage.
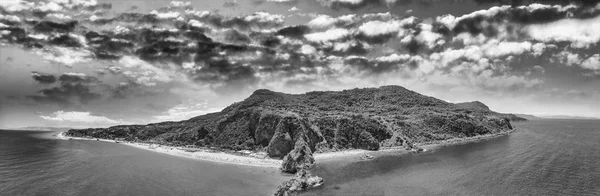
[0,0,598,115]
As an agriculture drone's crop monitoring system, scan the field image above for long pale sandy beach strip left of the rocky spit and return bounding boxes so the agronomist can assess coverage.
[56,132,283,168]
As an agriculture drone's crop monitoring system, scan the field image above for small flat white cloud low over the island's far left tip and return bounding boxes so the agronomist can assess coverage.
[40,111,122,124]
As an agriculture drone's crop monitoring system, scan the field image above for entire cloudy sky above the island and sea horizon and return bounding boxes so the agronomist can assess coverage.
[0,0,600,128]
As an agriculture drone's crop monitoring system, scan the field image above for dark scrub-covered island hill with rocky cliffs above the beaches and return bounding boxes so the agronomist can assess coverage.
[67,86,512,173]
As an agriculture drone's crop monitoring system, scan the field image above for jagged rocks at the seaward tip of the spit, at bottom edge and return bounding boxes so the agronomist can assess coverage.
[274,170,323,196]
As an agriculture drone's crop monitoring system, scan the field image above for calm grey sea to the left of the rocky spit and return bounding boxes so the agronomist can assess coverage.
[0,131,289,196]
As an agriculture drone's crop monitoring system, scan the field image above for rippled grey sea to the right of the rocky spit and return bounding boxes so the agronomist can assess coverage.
[301,120,600,196]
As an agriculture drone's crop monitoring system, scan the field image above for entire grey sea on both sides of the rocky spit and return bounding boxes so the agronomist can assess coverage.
[0,120,600,196]
